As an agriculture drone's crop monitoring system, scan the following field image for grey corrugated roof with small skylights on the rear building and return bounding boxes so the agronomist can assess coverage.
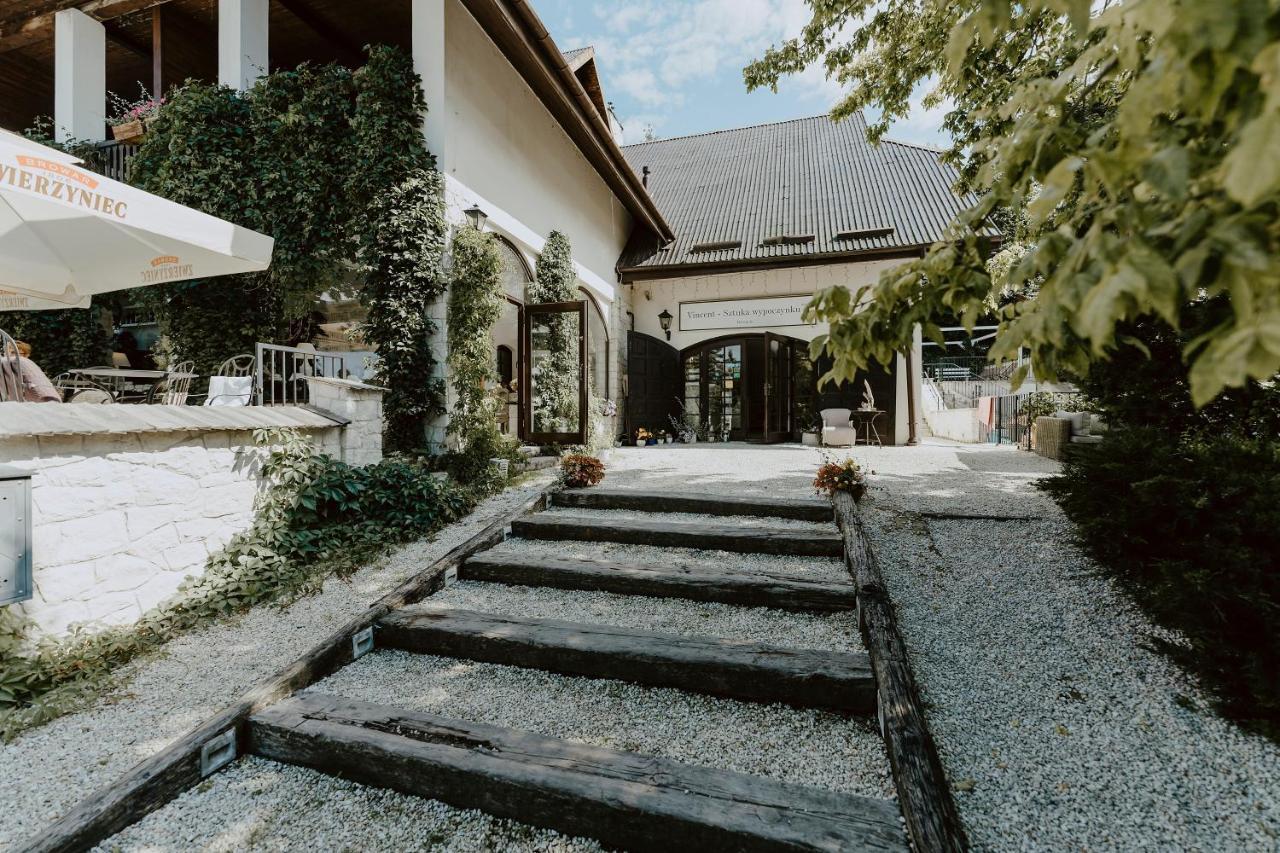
[620,115,974,270]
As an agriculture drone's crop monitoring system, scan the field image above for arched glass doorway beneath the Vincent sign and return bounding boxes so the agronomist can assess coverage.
[680,333,813,442]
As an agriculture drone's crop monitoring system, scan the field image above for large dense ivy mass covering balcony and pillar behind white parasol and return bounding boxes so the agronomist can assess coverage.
[131,46,447,438]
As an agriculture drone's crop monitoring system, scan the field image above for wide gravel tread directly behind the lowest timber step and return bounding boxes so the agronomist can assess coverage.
[308,651,892,797]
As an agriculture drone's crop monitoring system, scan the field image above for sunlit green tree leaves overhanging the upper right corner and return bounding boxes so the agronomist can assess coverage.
[745,0,1280,405]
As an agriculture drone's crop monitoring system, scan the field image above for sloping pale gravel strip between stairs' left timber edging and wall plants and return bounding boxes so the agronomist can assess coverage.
[0,476,549,850]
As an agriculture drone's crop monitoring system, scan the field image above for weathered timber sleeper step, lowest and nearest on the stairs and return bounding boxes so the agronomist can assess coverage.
[248,693,908,852]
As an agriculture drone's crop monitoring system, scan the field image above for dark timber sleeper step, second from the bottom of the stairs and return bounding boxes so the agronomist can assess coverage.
[376,606,876,715]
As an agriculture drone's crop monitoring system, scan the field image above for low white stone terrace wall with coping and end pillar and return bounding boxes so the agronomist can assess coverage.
[0,389,381,635]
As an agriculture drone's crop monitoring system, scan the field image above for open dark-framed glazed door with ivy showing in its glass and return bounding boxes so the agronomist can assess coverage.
[521,301,590,444]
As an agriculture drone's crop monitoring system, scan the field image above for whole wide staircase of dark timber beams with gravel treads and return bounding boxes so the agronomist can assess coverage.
[240,489,908,850]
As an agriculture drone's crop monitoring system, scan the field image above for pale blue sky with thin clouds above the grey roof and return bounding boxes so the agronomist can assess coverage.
[534,0,948,147]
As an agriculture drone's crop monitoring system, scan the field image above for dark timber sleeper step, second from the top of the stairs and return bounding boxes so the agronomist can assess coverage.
[511,514,844,557]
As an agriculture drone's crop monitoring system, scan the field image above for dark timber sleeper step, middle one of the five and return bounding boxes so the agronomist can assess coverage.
[458,551,858,612]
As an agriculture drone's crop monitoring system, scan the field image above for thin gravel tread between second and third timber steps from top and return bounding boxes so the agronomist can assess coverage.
[490,539,849,581]
